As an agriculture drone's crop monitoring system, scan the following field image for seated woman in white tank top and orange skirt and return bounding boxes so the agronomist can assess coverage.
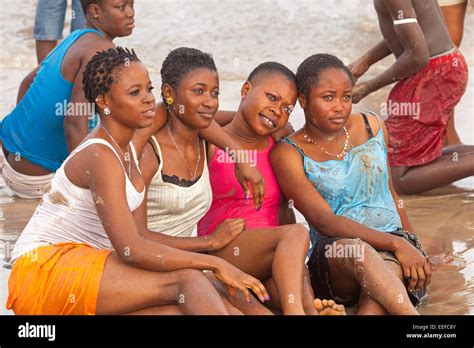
[7,43,268,315]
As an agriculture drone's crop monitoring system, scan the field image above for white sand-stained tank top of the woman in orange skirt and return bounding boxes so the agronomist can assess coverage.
[12,138,145,263]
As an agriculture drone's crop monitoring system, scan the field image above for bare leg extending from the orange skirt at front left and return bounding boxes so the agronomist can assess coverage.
[96,253,229,315]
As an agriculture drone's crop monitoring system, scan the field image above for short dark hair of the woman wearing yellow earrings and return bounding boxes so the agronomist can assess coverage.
[161,47,217,100]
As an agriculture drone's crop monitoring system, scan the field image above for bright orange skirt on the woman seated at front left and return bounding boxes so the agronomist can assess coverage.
[7,243,112,315]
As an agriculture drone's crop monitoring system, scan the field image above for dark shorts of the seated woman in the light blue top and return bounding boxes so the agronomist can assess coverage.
[307,230,427,307]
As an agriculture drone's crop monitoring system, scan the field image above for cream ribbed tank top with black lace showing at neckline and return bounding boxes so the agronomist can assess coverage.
[147,136,212,237]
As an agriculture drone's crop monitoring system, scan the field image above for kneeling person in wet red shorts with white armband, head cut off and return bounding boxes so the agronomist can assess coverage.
[351,0,474,194]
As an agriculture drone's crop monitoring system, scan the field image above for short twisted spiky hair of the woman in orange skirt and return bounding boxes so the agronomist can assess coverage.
[82,47,140,103]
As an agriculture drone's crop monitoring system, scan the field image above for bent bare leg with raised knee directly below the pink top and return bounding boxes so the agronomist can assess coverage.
[213,224,309,314]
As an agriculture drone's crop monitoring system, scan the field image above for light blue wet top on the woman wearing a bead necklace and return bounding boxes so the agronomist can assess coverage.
[282,116,402,255]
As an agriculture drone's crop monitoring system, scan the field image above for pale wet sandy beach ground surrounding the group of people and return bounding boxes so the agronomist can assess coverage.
[0,0,474,315]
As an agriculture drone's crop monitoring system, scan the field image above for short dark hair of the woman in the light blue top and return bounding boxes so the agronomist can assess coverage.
[296,53,355,98]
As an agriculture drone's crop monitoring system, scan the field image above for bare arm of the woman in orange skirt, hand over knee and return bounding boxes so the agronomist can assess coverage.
[83,145,268,301]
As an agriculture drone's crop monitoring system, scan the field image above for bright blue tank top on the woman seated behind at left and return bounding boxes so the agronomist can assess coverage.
[0,29,104,172]
